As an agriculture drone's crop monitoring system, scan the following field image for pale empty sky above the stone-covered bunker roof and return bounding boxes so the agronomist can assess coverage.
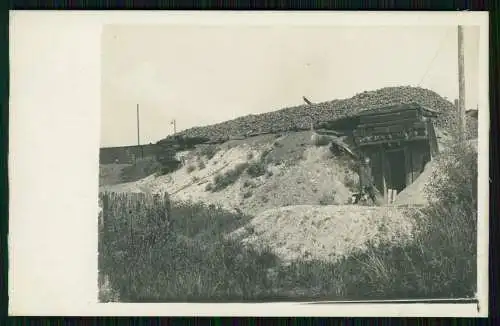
[101,25,479,147]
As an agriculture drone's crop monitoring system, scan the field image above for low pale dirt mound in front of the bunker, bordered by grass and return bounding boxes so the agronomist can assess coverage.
[230,205,414,261]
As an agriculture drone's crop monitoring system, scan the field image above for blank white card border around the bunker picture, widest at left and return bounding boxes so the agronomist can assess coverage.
[9,11,490,317]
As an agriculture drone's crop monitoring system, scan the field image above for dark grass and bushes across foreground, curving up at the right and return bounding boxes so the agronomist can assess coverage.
[99,145,477,302]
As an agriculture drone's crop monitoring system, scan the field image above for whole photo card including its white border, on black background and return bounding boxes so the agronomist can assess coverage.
[9,11,490,317]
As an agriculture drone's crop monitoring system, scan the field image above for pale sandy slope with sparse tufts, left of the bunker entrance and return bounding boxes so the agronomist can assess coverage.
[101,132,357,215]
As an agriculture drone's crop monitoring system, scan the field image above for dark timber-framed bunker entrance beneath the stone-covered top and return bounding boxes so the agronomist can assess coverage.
[323,103,438,203]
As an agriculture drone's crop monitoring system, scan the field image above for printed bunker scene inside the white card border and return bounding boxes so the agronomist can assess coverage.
[99,21,480,303]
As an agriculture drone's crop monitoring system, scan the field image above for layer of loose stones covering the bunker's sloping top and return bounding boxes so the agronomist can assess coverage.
[160,86,475,142]
